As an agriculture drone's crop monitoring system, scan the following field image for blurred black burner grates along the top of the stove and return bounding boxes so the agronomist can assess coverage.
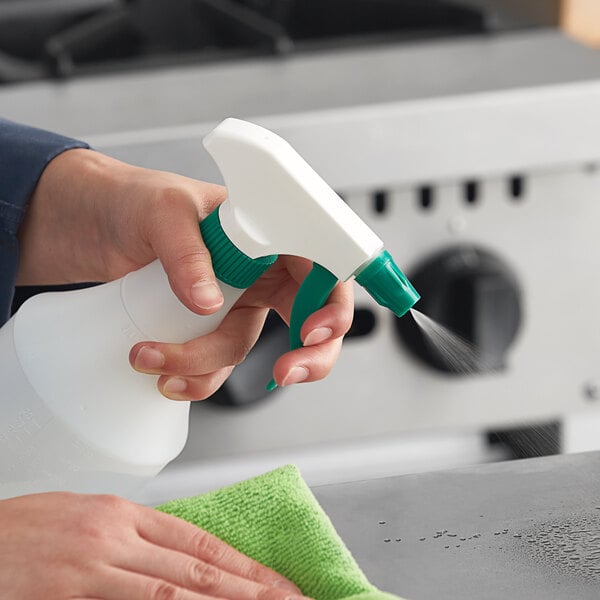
[0,0,560,85]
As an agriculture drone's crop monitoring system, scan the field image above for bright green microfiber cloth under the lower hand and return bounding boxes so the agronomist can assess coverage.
[158,465,398,600]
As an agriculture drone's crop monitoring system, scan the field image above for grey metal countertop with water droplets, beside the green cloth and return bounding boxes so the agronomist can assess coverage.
[313,452,600,600]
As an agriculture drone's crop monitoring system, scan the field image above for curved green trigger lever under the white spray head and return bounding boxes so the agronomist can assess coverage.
[267,263,338,391]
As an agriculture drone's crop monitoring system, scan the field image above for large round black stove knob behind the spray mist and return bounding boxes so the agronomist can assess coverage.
[396,246,521,374]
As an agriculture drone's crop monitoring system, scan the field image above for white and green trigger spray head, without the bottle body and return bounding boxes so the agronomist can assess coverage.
[202,119,419,389]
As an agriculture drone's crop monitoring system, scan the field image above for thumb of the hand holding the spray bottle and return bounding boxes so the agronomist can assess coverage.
[151,198,223,314]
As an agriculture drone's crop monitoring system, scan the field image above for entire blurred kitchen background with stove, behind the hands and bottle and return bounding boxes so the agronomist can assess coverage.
[0,0,600,503]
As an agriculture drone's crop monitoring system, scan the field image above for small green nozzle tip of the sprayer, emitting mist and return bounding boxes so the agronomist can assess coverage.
[356,250,421,317]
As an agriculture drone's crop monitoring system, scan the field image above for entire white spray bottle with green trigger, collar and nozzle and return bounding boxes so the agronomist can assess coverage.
[0,119,419,498]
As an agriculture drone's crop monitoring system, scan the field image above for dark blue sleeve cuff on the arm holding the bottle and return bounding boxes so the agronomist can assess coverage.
[0,119,89,325]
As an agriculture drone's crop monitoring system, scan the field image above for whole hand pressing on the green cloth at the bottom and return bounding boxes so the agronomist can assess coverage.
[0,492,308,600]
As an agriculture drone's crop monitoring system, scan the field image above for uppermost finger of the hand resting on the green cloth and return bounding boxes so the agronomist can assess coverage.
[137,507,301,594]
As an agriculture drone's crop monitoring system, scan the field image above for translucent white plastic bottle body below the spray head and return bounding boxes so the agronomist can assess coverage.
[0,261,244,498]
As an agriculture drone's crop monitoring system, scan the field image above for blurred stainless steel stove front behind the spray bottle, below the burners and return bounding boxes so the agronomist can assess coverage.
[0,3,600,502]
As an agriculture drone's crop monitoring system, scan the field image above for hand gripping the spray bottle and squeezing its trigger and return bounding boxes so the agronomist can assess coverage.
[18,149,353,400]
